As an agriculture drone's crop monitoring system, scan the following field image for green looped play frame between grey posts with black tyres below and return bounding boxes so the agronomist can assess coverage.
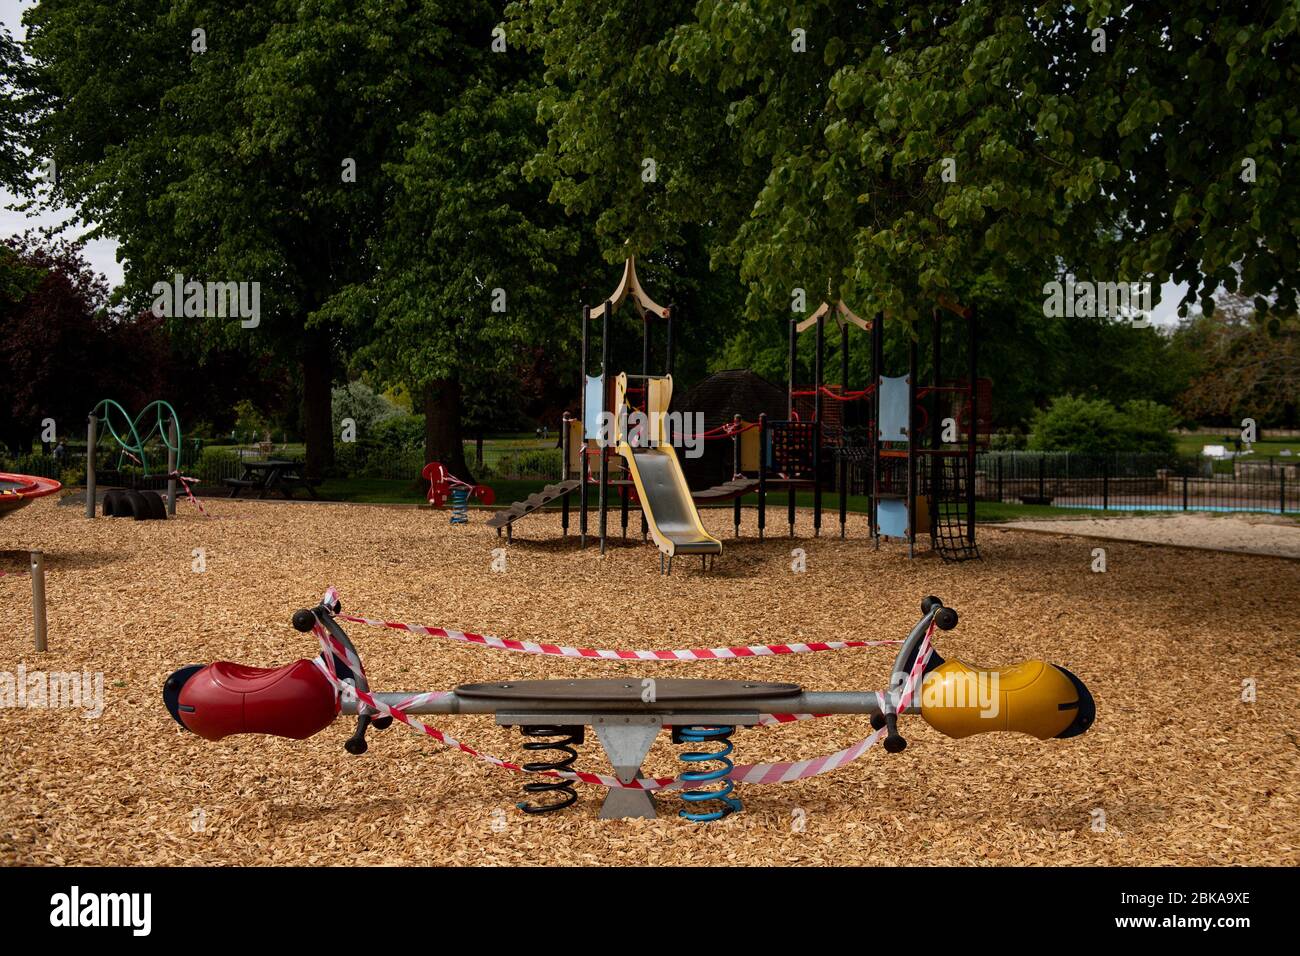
[86,398,181,522]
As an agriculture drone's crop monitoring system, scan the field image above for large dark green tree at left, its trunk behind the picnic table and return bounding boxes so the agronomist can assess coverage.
[26,0,506,472]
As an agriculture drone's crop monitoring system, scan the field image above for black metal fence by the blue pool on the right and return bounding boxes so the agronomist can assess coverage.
[975,451,1300,514]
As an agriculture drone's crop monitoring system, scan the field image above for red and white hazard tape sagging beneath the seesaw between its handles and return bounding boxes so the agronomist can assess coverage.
[312,616,935,791]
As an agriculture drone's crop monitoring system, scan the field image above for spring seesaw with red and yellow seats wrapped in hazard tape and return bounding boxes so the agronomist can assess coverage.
[163,589,1096,822]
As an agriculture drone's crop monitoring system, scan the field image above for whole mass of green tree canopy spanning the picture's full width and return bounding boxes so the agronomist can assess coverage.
[0,0,1300,460]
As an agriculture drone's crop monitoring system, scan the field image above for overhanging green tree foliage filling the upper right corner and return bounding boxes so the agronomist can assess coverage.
[512,0,1300,354]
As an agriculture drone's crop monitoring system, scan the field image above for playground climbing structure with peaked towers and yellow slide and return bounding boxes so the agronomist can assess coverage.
[489,258,992,571]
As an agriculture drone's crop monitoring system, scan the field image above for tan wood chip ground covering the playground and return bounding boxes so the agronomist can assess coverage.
[0,501,1300,866]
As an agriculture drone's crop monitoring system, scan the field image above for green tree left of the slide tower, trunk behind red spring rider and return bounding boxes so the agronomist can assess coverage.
[350,68,595,480]
